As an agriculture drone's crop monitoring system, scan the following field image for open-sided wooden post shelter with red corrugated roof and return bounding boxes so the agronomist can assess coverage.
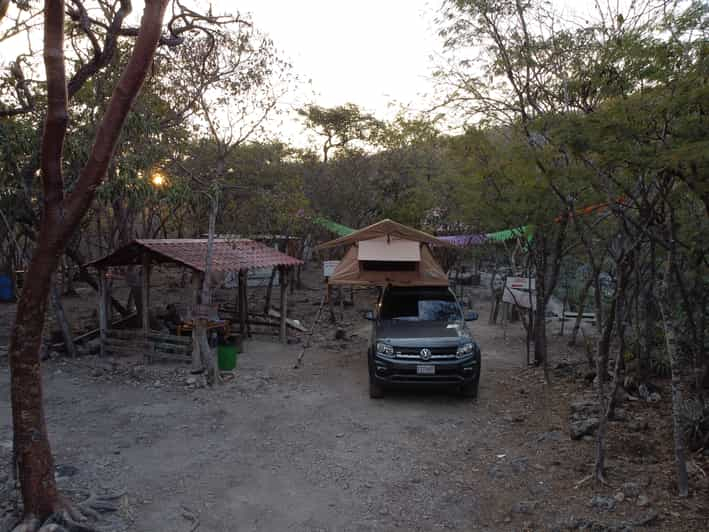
[87,239,302,358]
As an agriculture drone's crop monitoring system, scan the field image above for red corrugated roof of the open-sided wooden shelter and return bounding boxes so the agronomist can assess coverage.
[87,238,303,273]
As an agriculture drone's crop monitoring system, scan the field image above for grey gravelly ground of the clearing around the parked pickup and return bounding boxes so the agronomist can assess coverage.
[0,272,709,532]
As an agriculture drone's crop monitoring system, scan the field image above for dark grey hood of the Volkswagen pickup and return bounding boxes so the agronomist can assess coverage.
[375,320,470,347]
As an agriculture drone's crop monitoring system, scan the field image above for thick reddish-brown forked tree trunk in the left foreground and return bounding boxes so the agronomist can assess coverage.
[9,0,167,522]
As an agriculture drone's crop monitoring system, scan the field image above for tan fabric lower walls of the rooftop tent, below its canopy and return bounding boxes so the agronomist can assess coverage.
[328,242,448,286]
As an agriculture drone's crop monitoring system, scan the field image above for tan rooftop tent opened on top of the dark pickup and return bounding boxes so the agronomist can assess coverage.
[319,220,450,286]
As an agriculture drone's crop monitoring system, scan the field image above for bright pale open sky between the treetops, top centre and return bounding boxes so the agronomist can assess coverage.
[225,0,441,140]
